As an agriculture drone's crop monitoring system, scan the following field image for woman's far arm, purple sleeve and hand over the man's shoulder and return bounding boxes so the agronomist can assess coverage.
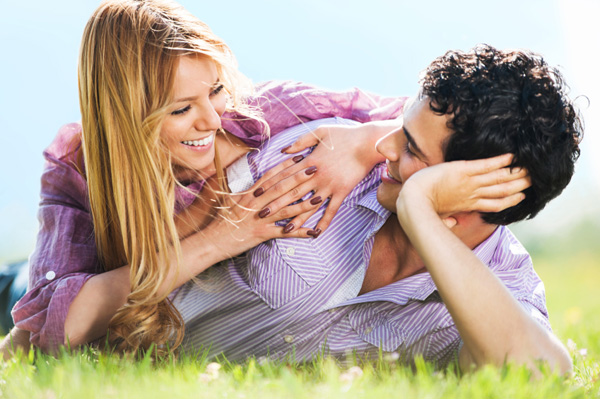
[223,81,407,235]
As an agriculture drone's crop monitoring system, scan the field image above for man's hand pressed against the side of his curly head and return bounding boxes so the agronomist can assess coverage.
[396,154,531,224]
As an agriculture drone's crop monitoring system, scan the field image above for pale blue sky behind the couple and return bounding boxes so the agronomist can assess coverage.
[0,0,600,261]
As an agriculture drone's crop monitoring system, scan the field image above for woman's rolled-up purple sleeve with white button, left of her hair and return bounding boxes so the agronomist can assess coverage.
[12,124,101,351]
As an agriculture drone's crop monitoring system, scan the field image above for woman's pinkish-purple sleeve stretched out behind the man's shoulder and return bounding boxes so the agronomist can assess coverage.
[222,81,407,146]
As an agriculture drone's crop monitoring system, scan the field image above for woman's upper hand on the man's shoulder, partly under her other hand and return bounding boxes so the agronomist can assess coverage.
[270,120,399,238]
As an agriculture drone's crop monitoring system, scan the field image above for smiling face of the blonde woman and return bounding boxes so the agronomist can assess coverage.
[160,55,227,177]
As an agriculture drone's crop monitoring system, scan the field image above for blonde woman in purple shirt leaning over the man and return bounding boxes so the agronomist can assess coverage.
[8,0,403,352]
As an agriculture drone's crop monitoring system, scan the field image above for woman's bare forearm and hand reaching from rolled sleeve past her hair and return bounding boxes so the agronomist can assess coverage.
[64,155,318,345]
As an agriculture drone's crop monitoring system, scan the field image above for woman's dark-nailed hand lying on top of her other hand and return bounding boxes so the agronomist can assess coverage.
[177,155,322,260]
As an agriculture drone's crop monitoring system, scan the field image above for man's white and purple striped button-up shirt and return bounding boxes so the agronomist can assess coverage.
[173,118,550,367]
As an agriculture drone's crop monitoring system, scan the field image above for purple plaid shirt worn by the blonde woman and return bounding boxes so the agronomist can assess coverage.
[12,82,406,351]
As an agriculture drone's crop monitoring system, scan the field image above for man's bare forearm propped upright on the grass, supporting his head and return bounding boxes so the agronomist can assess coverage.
[397,156,572,373]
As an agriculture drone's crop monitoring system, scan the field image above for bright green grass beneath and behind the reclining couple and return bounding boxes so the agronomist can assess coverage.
[0,227,600,399]
